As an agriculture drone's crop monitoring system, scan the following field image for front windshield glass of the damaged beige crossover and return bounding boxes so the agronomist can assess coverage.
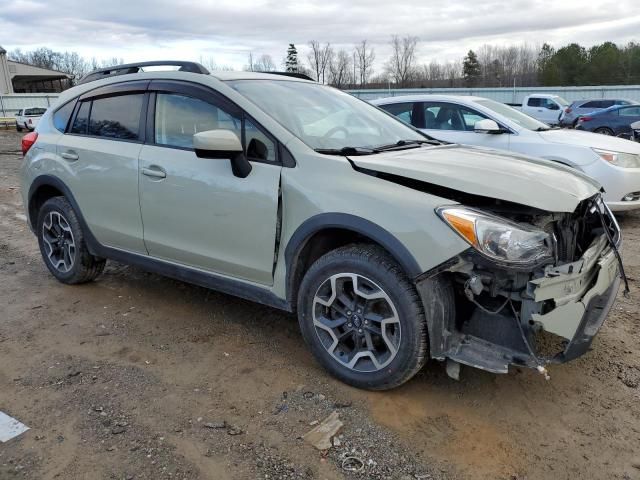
[229,80,427,150]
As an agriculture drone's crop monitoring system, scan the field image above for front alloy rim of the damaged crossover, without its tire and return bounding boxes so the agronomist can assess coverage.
[312,273,401,372]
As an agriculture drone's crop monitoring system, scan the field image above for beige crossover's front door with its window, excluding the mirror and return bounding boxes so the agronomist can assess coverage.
[140,81,281,284]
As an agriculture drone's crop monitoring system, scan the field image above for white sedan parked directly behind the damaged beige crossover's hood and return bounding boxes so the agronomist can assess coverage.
[371,95,640,211]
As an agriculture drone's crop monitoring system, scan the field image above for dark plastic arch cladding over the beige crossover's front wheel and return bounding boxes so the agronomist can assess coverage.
[285,213,423,304]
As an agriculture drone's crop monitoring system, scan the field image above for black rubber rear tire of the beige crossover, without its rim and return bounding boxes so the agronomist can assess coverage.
[36,197,106,285]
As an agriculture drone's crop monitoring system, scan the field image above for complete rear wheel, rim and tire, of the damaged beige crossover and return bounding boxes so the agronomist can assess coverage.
[36,197,106,284]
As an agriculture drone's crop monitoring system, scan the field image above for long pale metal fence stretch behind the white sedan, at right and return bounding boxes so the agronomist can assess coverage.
[348,85,640,104]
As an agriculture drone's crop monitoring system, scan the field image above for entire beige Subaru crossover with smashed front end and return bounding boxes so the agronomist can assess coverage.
[22,62,624,389]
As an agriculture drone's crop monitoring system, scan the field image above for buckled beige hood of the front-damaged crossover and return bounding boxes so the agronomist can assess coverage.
[350,145,600,212]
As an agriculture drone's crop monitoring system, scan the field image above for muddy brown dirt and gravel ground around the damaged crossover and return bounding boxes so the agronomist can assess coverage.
[0,130,640,480]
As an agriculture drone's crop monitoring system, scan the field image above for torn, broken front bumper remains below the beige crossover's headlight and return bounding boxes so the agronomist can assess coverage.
[417,235,620,378]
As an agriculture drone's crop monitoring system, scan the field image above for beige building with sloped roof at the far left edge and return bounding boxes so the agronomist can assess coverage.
[0,47,71,94]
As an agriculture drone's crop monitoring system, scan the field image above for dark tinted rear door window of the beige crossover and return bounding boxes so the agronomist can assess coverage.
[88,93,144,140]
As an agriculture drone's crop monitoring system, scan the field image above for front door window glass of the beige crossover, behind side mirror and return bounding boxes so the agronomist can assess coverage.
[155,93,240,151]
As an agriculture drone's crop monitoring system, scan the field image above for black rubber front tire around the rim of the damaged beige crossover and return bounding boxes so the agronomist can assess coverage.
[297,244,428,390]
